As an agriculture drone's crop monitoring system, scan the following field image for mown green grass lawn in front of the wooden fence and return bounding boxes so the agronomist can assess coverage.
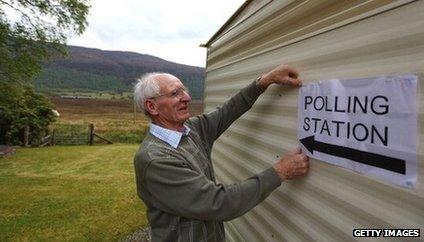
[0,144,147,241]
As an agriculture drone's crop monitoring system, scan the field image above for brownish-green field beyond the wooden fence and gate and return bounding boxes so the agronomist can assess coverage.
[51,98,149,144]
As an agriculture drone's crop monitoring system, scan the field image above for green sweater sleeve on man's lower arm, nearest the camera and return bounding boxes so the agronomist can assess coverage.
[143,156,281,221]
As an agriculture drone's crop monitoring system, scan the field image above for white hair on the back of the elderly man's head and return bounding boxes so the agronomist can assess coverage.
[134,72,163,115]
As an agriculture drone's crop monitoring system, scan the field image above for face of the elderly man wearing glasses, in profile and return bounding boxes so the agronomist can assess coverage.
[147,75,191,129]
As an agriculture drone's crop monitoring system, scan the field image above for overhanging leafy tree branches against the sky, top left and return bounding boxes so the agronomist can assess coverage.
[0,0,89,82]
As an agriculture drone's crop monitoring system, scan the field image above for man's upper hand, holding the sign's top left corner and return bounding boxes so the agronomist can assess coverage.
[258,65,302,88]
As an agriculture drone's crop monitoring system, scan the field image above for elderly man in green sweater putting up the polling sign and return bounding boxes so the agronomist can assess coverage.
[134,65,309,241]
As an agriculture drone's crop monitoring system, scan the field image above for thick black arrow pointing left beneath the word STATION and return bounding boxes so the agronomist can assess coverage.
[300,135,406,175]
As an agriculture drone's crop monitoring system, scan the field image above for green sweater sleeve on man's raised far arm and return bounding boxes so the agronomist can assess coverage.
[189,81,265,149]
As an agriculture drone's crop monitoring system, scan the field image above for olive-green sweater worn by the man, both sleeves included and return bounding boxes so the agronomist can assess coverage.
[134,82,281,241]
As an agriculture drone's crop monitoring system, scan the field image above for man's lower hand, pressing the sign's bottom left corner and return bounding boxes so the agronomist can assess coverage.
[274,148,309,181]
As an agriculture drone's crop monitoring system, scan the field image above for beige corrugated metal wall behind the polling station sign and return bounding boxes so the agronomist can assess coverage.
[205,0,424,241]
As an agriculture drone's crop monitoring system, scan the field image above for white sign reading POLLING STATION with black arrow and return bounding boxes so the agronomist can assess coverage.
[298,75,418,188]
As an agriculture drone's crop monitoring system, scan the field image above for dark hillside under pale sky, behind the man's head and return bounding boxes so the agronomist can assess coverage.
[34,46,205,99]
